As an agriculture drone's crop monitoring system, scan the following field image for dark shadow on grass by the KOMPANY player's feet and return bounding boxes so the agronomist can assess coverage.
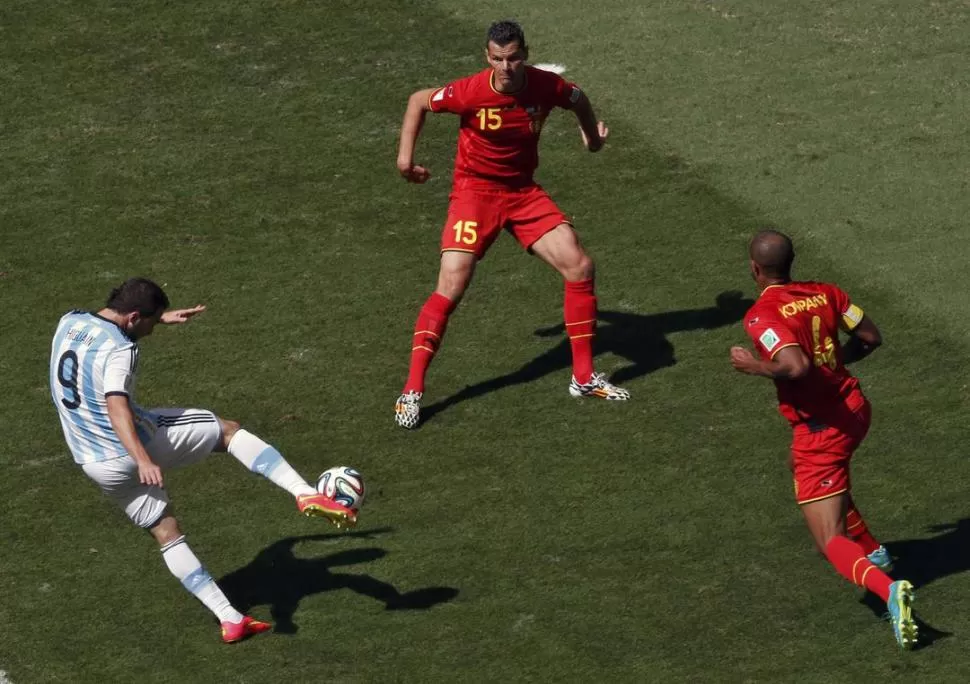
[864,518,970,648]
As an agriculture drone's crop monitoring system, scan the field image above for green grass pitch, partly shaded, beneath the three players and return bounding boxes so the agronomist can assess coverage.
[0,0,970,684]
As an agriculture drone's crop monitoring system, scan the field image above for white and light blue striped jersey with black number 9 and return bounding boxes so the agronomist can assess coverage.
[50,311,154,464]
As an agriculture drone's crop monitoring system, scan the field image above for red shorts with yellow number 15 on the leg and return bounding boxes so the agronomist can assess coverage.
[441,185,570,259]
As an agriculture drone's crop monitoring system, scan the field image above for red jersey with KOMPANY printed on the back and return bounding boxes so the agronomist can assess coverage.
[744,282,864,425]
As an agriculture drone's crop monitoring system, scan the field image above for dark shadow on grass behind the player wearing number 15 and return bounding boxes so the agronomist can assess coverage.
[421,291,754,423]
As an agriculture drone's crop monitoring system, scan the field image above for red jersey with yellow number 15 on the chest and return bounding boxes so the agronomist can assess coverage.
[429,66,582,188]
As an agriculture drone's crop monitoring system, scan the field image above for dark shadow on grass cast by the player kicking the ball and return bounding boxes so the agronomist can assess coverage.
[217,528,458,634]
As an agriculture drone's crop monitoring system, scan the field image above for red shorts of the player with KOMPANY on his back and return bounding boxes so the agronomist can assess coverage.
[791,395,872,505]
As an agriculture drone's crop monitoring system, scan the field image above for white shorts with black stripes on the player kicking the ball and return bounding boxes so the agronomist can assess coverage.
[81,408,222,528]
